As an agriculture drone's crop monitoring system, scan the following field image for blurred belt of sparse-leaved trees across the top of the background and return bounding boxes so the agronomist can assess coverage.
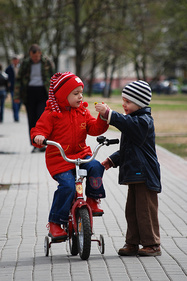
[0,0,187,87]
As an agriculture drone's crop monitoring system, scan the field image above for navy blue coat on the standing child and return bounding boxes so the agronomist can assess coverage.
[110,107,161,192]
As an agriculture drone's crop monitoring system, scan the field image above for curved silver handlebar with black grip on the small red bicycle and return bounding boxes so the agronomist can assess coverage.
[43,136,119,164]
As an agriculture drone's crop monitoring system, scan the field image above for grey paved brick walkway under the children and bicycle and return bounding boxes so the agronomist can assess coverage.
[0,107,187,281]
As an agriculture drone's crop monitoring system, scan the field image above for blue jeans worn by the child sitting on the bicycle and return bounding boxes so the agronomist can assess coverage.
[49,156,105,224]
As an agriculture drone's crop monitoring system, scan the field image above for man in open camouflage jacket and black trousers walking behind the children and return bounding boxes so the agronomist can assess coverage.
[14,44,53,152]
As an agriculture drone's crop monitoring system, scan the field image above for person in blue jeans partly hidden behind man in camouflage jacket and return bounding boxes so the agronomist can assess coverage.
[5,56,21,122]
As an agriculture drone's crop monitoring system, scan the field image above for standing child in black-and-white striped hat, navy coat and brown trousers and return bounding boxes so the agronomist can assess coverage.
[95,80,161,256]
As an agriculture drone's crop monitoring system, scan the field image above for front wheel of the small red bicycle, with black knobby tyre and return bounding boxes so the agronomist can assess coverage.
[76,208,92,260]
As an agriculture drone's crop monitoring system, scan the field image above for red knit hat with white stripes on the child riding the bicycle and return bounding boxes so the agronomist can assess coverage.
[48,72,84,117]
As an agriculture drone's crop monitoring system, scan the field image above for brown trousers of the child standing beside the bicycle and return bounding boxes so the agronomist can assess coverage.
[125,183,160,246]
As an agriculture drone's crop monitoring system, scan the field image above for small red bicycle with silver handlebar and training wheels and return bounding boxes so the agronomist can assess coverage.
[44,136,119,260]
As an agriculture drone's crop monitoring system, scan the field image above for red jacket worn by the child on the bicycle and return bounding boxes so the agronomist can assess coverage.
[31,103,108,177]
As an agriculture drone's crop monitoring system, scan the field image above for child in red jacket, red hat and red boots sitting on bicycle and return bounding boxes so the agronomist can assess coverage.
[31,72,108,239]
